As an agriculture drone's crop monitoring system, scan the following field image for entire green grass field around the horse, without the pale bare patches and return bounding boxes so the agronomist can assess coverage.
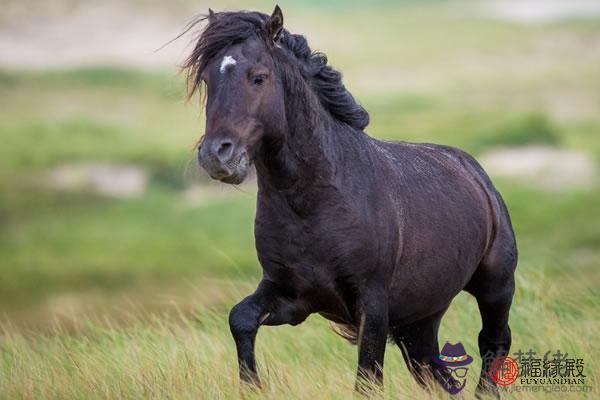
[0,1,600,399]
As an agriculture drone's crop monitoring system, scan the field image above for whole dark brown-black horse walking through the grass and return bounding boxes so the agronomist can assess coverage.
[182,6,517,395]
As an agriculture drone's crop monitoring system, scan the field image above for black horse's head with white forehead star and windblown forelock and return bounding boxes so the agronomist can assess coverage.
[187,7,285,184]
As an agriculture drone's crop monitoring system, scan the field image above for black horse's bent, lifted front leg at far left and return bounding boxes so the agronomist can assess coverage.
[229,280,309,387]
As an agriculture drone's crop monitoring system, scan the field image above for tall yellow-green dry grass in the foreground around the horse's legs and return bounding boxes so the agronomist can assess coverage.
[0,265,600,400]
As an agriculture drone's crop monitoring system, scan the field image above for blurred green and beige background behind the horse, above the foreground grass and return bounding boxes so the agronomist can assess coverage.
[0,0,600,331]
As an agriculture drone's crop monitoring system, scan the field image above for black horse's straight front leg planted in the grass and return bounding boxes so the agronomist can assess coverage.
[355,289,389,394]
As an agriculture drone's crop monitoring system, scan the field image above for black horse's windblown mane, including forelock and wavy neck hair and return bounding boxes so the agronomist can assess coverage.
[182,11,369,130]
